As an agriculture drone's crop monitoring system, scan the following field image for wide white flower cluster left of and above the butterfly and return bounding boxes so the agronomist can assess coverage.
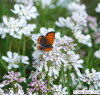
[3,16,36,39]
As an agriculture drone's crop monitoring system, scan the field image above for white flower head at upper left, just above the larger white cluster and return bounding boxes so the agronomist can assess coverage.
[11,4,39,20]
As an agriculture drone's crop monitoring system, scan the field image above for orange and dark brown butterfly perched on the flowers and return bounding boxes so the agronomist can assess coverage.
[37,32,55,51]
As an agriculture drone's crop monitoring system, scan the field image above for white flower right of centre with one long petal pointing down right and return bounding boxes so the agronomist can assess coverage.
[63,51,83,76]
